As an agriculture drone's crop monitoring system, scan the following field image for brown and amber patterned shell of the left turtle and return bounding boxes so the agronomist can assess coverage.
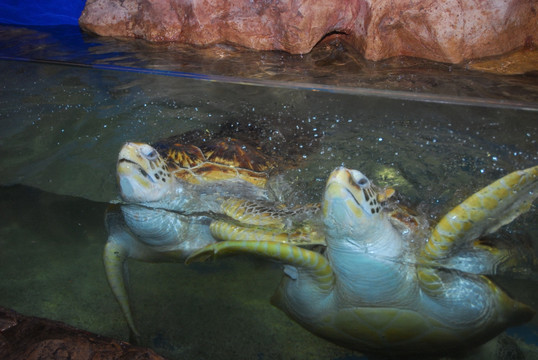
[153,138,275,187]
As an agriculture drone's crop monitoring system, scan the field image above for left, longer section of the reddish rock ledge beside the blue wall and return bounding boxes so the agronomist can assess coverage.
[79,0,362,53]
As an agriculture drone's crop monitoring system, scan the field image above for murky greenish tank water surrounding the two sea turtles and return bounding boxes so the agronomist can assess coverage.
[0,26,538,359]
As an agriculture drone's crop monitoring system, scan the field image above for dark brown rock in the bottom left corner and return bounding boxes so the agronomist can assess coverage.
[0,307,164,360]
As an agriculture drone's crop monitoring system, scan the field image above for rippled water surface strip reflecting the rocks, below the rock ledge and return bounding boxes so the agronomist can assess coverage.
[0,25,538,109]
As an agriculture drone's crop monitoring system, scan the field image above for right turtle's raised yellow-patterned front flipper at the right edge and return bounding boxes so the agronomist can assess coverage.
[421,166,538,260]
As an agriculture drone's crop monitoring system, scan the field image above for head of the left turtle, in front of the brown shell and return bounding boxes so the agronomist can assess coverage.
[116,142,173,202]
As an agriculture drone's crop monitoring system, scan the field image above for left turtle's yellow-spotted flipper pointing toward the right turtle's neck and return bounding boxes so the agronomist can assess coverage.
[209,198,325,245]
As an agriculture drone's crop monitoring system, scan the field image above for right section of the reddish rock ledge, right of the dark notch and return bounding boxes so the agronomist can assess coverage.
[365,0,538,63]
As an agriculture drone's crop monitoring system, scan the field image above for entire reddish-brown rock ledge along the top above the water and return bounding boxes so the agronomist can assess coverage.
[79,0,538,63]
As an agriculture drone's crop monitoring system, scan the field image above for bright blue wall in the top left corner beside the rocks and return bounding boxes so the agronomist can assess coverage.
[0,0,86,25]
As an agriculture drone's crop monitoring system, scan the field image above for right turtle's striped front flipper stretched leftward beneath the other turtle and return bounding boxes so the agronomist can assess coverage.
[186,240,334,289]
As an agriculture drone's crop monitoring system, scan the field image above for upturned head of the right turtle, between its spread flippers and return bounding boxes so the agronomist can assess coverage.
[322,167,381,246]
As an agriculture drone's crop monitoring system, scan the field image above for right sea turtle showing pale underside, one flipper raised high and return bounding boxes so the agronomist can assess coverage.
[187,166,538,356]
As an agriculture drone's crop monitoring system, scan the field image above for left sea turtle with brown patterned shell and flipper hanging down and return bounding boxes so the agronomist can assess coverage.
[103,137,323,339]
